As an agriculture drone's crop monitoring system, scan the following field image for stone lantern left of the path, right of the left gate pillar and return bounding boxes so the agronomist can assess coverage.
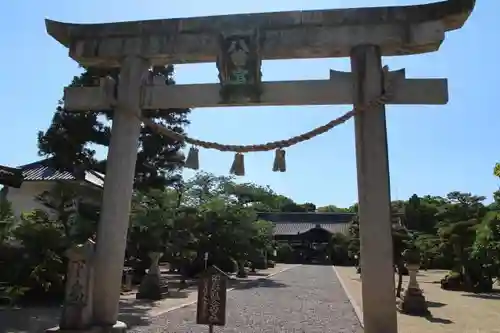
[136,252,168,300]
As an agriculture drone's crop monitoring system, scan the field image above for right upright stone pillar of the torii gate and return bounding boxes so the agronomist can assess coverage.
[351,45,398,333]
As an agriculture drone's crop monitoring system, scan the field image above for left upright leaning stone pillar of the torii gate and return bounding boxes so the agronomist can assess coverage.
[94,56,149,330]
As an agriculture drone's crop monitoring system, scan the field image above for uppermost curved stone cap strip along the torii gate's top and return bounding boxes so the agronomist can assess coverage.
[46,0,476,41]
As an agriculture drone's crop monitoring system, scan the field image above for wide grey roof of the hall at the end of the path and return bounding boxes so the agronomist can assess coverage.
[257,212,356,236]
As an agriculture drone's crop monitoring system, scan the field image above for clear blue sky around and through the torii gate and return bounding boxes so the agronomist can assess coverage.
[0,0,500,206]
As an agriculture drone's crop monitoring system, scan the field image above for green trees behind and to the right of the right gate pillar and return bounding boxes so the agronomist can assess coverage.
[342,187,500,290]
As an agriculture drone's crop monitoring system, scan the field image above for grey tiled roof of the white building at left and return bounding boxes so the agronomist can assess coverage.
[19,160,104,187]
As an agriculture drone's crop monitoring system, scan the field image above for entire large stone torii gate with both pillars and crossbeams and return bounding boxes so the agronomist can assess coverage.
[46,0,475,333]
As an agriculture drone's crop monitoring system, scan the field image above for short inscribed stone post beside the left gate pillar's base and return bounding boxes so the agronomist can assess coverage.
[47,239,95,332]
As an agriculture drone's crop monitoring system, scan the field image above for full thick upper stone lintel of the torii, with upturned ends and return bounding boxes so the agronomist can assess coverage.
[46,0,475,67]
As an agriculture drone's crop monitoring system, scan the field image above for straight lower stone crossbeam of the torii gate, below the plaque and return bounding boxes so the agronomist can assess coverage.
[64,69,448,111]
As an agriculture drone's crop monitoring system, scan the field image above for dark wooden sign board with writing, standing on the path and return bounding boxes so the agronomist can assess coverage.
[196,268,227,326]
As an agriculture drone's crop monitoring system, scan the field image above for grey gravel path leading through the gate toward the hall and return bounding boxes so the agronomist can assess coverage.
[129,266,363,333]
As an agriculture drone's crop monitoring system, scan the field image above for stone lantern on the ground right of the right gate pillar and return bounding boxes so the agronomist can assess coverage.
[398,249,429,316]
